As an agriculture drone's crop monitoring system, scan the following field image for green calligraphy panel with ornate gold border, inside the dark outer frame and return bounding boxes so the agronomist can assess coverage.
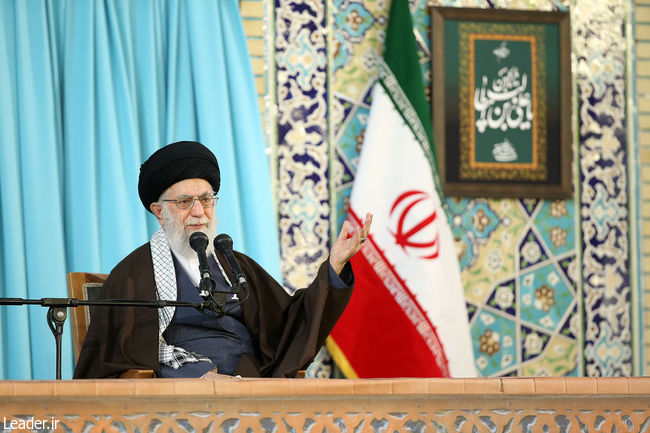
[458,27,548,181]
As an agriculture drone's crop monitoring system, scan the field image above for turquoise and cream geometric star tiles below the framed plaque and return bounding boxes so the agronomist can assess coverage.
[464,200,580,376]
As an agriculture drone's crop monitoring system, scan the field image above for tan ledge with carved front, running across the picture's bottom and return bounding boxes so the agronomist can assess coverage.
[0,378,650,433]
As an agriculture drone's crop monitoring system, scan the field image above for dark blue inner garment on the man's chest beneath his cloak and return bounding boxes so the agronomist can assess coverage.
[160,256,255,377]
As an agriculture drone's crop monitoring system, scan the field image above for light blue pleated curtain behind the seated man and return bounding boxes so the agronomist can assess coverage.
[0,0,280,379]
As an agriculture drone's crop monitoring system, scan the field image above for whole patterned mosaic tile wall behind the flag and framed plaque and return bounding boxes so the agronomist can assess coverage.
[268,0,632,377]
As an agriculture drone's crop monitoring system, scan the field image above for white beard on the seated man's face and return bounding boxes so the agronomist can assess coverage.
[162,205,217,260]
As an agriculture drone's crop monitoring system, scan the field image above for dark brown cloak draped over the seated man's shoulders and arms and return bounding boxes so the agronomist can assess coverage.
[74,243,352,379]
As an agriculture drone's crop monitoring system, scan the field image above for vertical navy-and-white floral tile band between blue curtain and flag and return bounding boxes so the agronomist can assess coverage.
[274,0,330,290]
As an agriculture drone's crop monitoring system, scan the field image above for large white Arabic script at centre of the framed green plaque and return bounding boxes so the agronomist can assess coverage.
[474,66,533,134]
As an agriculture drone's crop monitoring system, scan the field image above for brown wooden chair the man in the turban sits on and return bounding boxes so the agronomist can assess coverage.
[67,272,153,379]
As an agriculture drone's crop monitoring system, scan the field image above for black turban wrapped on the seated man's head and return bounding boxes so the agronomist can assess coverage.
[138,141,221,212]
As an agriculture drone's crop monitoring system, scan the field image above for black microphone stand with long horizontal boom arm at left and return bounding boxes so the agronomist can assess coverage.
[0,298,223,380]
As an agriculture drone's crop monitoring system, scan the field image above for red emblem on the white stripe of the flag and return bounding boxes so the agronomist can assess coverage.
[389,190,439,259]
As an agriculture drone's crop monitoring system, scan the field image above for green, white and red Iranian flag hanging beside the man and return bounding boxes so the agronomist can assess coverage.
[327,0,476,378]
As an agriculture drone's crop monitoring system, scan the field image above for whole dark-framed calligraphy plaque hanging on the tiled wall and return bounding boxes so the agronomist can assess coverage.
[431,7,572,198]
